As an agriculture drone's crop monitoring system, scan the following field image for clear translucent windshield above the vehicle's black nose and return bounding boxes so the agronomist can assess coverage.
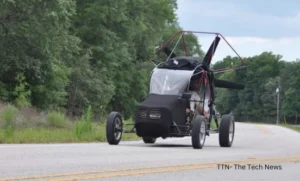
[150,68,193,95]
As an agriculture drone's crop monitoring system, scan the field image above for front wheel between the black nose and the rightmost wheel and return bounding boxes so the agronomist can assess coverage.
[192,115,206,149]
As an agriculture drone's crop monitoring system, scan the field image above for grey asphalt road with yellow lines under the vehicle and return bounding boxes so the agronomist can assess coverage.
[0,123,300,181]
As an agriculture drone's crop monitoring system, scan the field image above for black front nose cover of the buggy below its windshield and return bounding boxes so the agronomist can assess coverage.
[134,94,188,138]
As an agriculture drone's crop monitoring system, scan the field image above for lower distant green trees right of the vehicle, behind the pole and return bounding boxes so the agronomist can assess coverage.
[214,52,300,124]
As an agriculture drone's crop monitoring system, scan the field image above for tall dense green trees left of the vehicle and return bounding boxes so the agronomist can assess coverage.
[0,0,200,118]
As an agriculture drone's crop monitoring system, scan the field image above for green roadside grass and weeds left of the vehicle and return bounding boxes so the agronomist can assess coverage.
[0,104,140,143]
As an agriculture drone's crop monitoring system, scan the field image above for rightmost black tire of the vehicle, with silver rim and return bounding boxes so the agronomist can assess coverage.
[219,114,235,147]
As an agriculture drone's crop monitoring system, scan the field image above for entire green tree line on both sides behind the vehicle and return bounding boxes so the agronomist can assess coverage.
[0,0,300,124]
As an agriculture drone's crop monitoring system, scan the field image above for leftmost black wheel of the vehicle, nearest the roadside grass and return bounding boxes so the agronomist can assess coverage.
[106,112,123,145]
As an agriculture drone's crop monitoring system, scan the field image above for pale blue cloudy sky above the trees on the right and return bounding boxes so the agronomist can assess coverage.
[177,0,300,63]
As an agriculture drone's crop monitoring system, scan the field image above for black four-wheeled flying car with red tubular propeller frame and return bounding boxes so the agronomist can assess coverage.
[106,31,247,149]
